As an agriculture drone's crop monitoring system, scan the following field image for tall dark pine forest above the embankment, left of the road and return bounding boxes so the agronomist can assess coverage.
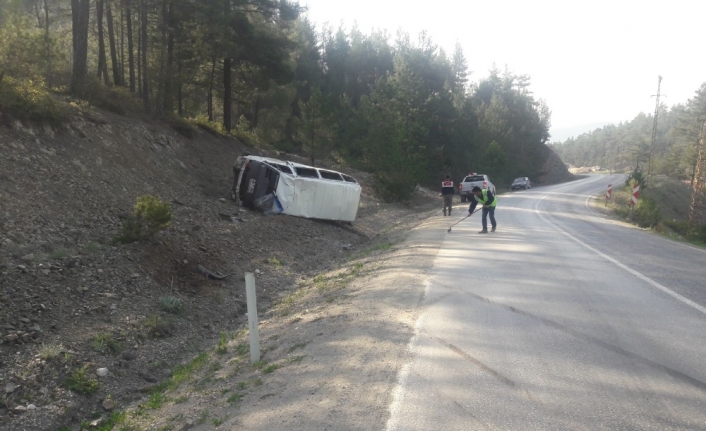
[0,0,550,200]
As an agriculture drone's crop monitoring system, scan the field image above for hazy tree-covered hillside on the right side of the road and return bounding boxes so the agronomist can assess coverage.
[551,83,706,183]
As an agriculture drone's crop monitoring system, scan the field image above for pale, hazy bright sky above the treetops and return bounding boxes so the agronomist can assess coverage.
[300,0,706,140]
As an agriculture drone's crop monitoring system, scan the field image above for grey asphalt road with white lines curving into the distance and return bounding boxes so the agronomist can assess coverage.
[387,176,706,431]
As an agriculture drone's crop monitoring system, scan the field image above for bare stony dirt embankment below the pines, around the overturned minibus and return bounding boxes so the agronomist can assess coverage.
[0,112,438,430]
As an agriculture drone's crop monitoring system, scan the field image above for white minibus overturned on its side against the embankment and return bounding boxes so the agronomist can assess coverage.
[232,156,361,222]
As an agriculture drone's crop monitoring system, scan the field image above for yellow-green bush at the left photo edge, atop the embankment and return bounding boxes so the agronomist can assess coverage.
[0,76,69,126]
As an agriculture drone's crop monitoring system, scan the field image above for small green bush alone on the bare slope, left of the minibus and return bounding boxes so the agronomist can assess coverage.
[114,195,172,244]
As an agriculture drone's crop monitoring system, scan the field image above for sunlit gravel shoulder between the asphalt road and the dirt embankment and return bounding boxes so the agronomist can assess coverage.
[124,211,448,430]
